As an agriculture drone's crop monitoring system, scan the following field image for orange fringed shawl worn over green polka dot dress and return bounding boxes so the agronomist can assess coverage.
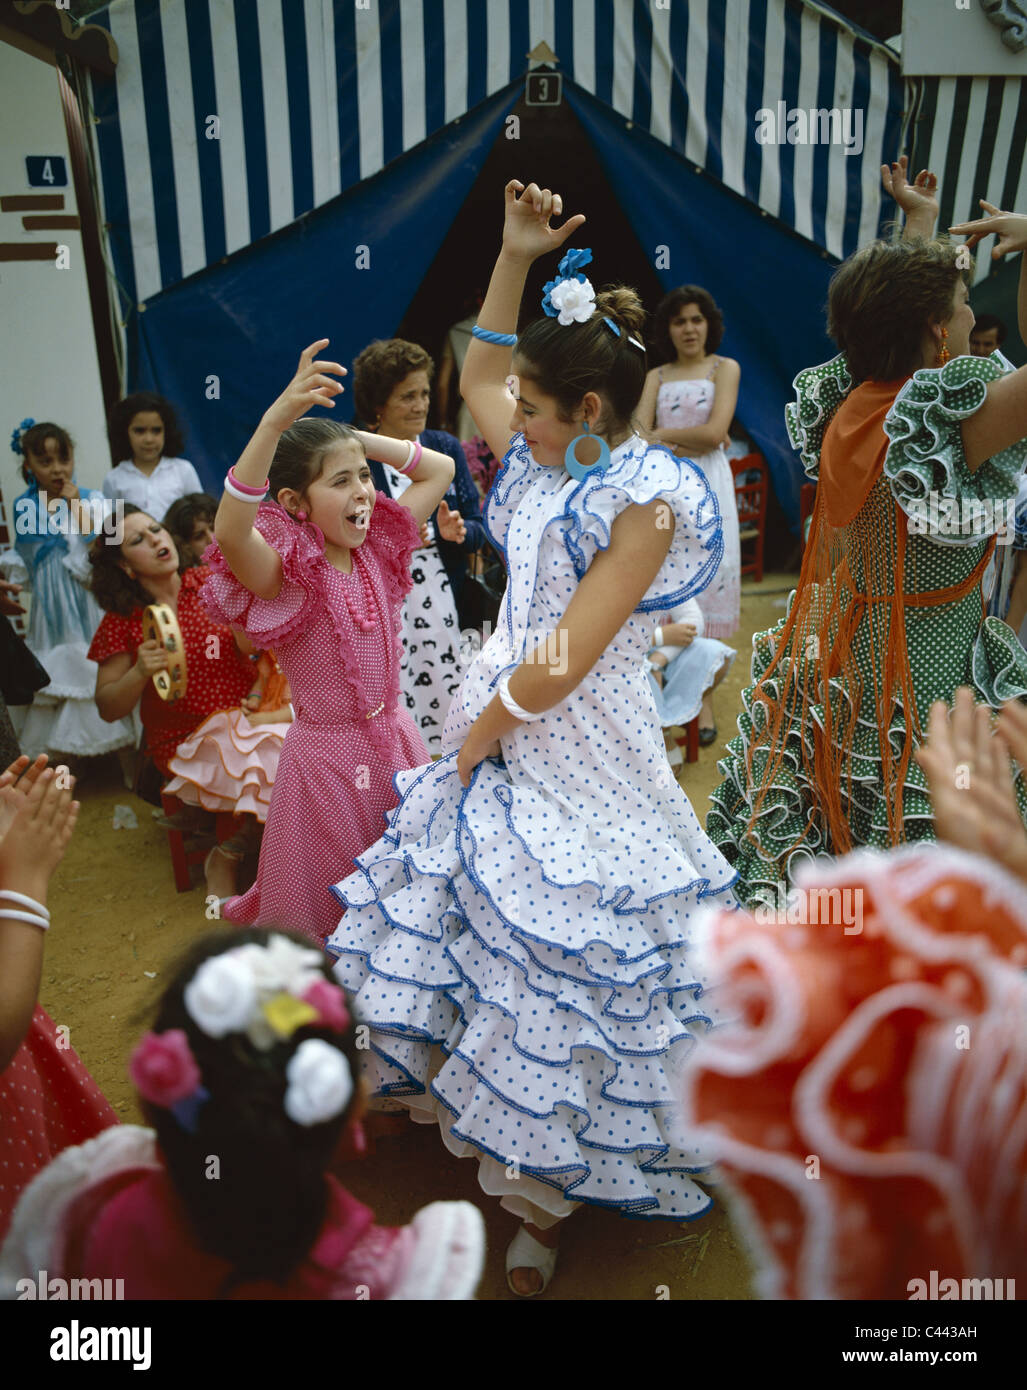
[746,379,995,855]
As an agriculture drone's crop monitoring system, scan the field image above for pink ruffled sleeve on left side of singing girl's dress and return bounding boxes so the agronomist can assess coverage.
[200,502,328,648]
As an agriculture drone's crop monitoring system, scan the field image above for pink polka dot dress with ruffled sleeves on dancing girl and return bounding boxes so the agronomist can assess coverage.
[203,492,431,944]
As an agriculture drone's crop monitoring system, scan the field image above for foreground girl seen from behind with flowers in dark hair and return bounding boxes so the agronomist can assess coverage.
[0,930,485,1301]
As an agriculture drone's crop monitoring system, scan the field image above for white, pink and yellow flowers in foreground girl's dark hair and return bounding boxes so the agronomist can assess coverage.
[136,935,353,1133]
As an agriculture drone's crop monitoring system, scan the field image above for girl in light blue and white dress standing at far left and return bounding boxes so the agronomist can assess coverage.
[4,420,138,758]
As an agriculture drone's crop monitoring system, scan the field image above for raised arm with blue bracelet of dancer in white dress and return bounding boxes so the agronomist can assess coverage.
[460,179,585,459]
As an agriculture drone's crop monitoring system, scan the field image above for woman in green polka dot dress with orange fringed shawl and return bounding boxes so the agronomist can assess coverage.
[706,170,1027,906]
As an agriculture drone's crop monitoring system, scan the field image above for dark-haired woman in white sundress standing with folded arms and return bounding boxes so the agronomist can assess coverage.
[638,285,742,744]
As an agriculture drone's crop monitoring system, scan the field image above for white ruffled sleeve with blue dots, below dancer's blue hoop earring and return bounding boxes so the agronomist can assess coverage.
[559,439,724,613]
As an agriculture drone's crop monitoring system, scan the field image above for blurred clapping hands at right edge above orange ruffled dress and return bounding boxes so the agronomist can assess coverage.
[916,687,1027,880]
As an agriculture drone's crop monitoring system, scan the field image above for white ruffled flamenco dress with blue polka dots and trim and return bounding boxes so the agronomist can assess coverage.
[328,435,735,1225]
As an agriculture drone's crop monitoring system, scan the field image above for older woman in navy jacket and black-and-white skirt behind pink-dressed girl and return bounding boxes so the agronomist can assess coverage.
[353,338,486,755]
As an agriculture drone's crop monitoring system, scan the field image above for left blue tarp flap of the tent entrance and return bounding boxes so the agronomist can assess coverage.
[129,82,523,483]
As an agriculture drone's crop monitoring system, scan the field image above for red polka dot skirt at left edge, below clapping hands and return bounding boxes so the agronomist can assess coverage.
[0,1005,118,1240]
